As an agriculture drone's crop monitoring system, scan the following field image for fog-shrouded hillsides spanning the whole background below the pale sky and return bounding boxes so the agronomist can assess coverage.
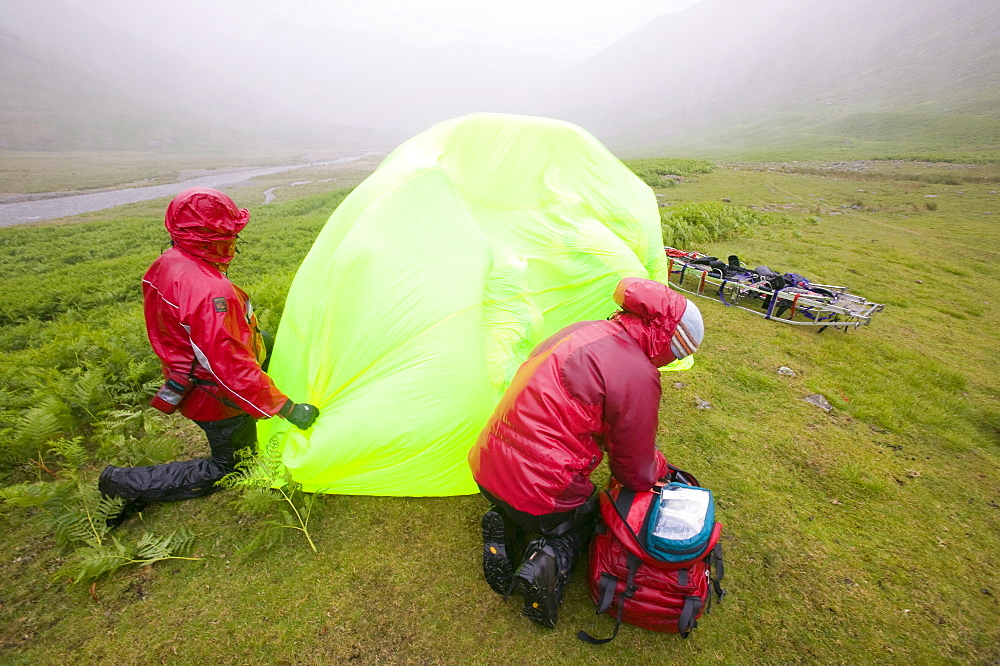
[0,0,1000,156]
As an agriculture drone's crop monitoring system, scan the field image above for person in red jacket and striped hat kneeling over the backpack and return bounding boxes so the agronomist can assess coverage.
[469,278,704,627]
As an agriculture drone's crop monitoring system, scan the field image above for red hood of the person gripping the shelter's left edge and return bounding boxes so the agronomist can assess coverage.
[164,187,250,264]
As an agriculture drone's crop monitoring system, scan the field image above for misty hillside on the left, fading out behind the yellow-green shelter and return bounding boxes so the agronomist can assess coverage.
[0,0,564,150]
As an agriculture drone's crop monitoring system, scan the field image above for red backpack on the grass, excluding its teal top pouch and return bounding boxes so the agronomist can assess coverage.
[577,466,725,645]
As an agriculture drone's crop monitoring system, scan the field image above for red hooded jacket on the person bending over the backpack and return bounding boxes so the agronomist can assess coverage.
[469,278,688,516]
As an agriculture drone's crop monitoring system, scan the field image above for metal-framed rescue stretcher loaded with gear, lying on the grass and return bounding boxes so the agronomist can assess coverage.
[664,247,885,333]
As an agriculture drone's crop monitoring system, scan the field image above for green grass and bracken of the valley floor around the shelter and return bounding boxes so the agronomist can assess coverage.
[0,158,1000,664]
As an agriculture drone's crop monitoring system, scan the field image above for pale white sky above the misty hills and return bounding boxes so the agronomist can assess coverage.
[62,0,698,60]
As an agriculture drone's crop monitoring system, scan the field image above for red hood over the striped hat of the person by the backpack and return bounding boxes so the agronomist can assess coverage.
[612,278,688,367]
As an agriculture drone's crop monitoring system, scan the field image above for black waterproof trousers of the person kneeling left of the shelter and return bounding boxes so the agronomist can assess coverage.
[98,414,257,504]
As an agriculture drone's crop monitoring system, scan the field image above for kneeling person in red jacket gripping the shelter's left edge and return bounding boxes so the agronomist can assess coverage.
[98,188,319,521]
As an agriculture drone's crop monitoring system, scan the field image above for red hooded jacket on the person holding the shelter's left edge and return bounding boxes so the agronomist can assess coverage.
[142,188,288,421]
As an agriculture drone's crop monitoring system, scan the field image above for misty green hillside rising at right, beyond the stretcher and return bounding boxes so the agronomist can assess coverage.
[553,0,1000,153]
